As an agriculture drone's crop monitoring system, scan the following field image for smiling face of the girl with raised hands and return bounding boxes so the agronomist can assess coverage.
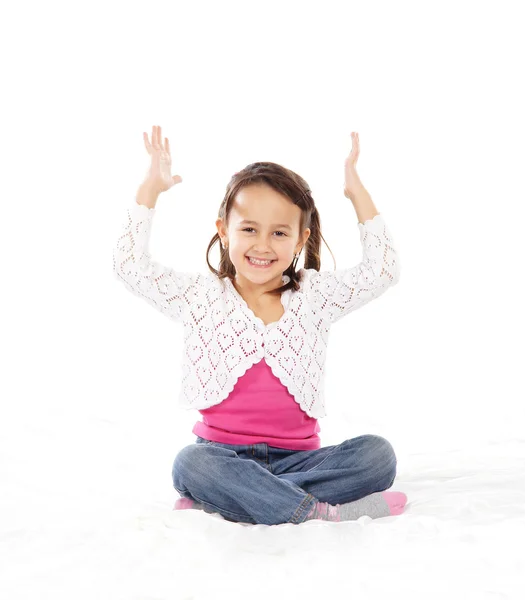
[216,184,310,297]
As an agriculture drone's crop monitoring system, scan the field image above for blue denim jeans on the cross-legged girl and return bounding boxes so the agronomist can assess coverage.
[172,435,397,525]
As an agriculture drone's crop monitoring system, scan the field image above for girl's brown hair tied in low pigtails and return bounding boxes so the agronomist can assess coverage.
[206,162,335,295]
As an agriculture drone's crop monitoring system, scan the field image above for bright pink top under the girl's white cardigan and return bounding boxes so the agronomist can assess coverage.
[192,358,321,450]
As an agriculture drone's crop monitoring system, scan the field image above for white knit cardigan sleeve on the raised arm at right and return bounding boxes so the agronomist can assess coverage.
[304,214,400,323]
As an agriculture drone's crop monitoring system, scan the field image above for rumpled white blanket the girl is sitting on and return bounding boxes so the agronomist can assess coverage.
[0,409,525,600]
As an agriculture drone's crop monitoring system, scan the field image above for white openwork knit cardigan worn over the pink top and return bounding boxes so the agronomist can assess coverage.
[113,201,400,418]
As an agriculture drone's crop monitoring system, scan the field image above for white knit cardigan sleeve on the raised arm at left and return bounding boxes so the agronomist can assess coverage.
[113,201,203,322]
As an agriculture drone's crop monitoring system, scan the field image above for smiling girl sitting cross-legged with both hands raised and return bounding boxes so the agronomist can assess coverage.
[113,127,407,525]
